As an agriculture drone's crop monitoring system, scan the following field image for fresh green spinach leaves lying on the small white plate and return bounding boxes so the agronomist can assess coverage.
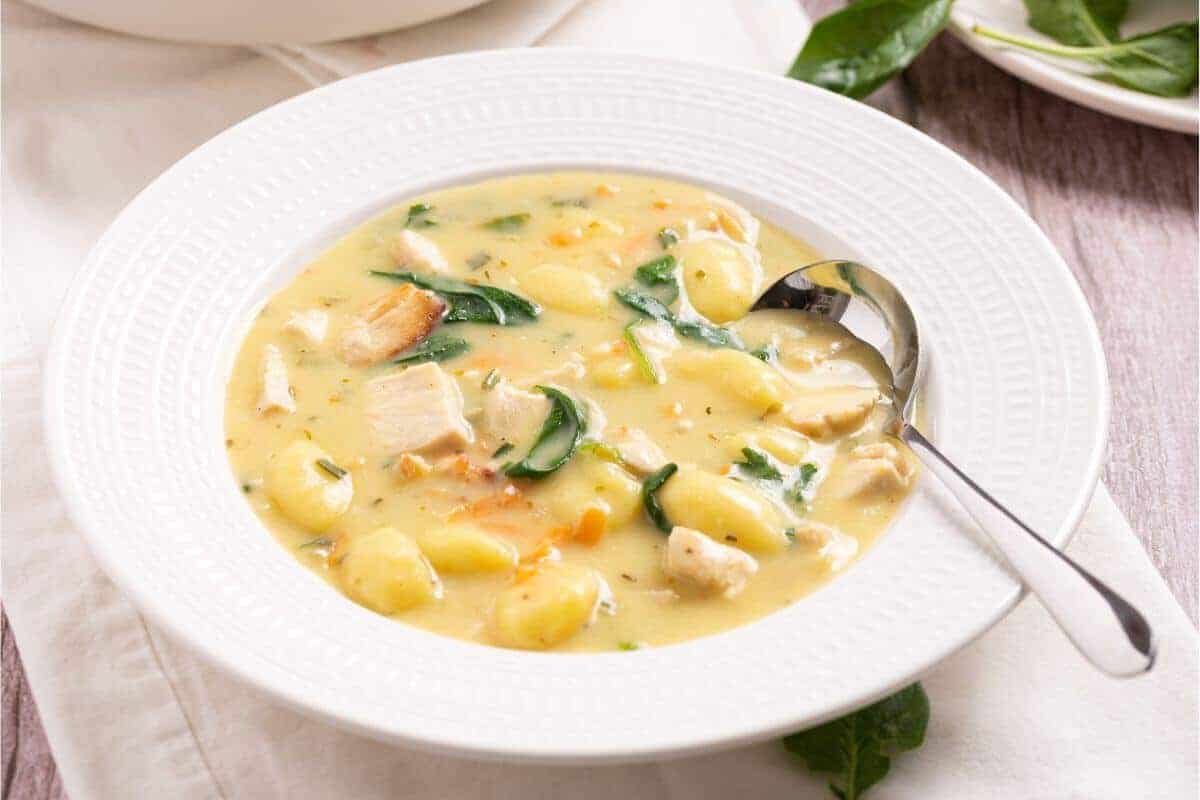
[972,0,1198,97]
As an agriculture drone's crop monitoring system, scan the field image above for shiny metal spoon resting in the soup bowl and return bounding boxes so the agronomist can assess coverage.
[751,260,1156,676]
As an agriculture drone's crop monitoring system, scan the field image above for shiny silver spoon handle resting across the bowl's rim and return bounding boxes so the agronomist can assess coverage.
[900,425,1156,678]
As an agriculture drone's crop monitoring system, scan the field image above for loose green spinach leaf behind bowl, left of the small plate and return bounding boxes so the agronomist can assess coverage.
[787,0,952,100]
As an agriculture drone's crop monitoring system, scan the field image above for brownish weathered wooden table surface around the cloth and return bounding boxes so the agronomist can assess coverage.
[0,10,1200,800]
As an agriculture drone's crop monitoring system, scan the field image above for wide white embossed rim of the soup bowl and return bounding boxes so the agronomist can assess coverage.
[46,49,1109,763]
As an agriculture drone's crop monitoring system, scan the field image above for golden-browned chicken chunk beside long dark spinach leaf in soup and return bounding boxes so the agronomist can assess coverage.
[341,283,445,367]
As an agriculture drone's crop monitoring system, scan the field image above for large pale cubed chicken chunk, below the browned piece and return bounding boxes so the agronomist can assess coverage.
[365,362,474,453]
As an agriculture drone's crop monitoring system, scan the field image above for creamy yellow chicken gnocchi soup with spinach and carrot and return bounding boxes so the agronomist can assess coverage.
[226,173,914,650]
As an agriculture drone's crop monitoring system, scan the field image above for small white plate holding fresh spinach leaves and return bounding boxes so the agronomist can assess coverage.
[950,0,1200,136]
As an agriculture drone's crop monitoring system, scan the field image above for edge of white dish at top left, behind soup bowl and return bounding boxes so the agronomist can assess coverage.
[19,0,487,44]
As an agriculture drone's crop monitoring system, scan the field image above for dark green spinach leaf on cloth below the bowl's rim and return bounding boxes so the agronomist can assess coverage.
[784,684,929,800]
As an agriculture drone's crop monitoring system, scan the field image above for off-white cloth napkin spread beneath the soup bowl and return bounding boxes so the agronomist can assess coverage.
[2,0,1198,800]
